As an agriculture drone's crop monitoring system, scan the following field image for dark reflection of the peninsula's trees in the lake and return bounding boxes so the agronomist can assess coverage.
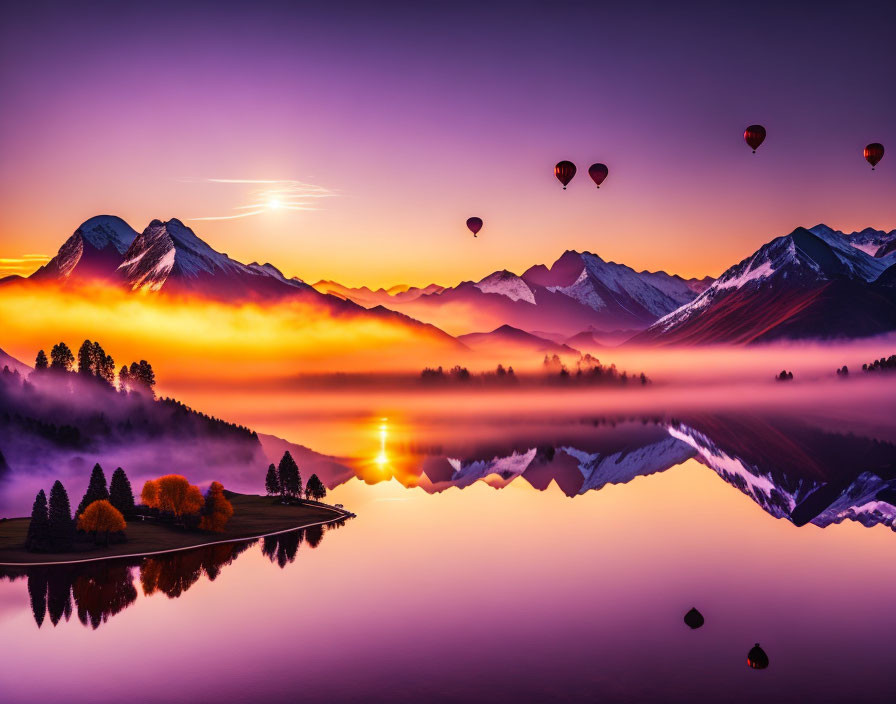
[0,520,345,629]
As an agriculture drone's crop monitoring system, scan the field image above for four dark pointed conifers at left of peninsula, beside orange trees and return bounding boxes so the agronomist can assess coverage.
[25,464,136,552]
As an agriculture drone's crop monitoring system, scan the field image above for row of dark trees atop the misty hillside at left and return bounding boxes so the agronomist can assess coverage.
[34,340,156,396]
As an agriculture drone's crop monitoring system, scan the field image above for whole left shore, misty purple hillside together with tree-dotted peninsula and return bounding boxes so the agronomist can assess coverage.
[0,340,351,565]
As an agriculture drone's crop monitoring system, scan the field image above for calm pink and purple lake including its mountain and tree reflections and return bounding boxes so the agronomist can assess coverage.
[0,387,896,702]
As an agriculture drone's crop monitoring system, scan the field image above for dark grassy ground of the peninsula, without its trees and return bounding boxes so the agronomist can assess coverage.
[0,494,350,566]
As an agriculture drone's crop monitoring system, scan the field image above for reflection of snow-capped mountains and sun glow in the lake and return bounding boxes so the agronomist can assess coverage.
[332,413,896,530]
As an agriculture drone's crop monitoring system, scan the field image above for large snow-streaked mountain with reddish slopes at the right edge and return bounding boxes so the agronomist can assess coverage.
[631,225,896,344]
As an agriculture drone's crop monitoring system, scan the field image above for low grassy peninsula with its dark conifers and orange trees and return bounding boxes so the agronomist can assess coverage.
[0,452,353,566]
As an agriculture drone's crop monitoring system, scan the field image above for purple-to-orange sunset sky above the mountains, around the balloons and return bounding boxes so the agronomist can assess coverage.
[0,0,896,287]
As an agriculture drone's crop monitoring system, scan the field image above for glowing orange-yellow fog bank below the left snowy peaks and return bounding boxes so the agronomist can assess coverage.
[0,285,466,384]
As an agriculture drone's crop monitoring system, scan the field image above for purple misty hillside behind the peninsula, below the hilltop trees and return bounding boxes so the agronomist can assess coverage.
[0,371,342,517]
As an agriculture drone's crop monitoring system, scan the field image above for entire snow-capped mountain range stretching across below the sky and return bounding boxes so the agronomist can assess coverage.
[3,215,896,352]
